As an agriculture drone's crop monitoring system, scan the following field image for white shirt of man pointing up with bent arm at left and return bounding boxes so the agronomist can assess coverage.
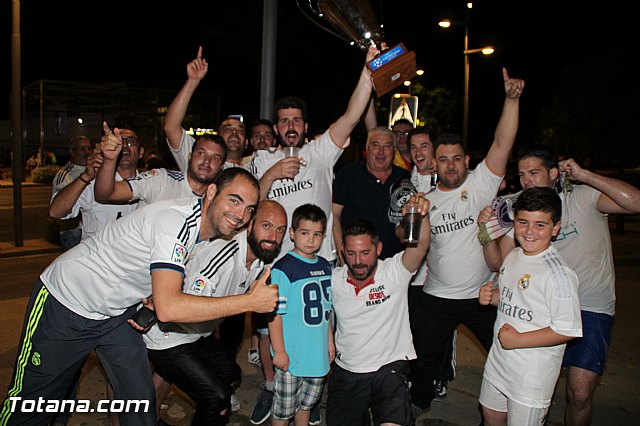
[125,169,198,206]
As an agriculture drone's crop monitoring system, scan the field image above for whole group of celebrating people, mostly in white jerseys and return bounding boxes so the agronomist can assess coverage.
[0,46,640,426]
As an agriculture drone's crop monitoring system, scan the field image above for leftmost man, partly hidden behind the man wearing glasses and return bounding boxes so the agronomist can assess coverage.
[51,136,93,250]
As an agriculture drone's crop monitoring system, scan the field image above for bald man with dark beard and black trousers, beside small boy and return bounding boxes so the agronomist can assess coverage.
[144,200,287,425]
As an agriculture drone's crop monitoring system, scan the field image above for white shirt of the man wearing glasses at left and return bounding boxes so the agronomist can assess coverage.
[53,172,138,240]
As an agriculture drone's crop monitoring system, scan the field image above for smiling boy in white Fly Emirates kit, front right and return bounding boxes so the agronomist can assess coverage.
[478,188,582,426]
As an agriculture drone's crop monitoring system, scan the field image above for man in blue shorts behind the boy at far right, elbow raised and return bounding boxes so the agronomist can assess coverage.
[485,147,640,425]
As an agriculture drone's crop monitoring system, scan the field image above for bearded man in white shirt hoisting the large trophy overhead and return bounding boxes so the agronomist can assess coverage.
[251,47,378,262]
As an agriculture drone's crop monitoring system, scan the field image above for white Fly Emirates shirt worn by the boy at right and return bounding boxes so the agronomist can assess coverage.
[484,245,582,408]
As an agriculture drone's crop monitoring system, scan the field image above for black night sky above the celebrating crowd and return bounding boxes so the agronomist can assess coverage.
[0,0,632,149]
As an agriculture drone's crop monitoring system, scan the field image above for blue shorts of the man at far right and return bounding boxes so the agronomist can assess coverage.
[562,311,614,376]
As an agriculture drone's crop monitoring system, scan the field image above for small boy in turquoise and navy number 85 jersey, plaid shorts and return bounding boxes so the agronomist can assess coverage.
[269,204,335,426]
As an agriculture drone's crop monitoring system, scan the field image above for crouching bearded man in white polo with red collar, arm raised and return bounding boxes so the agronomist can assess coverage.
[327,195,430,426]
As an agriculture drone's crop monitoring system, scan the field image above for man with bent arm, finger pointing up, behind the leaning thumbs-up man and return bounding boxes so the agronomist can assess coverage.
[94,123,226,205]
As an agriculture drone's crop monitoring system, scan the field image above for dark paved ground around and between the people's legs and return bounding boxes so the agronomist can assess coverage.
[0,216,640,426]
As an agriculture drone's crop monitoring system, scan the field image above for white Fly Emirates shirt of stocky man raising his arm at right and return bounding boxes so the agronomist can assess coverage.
[424,161,502,299]
